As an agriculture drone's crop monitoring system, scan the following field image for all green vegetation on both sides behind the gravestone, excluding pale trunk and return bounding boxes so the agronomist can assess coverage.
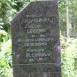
[0,0,77,77]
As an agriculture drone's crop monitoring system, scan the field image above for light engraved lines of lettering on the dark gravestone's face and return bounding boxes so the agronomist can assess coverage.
[17,15,54,63]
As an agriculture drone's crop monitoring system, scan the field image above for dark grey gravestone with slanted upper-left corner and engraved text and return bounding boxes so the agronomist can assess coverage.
[11,0,61,77]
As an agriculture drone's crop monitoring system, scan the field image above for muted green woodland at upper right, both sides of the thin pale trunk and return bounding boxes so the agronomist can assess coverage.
[59,0,77,37]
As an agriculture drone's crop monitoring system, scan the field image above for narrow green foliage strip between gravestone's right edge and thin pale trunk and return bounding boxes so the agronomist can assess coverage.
[59,0,66,36]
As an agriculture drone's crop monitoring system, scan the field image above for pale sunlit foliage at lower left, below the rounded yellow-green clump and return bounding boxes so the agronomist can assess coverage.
[0,39,13,77]
